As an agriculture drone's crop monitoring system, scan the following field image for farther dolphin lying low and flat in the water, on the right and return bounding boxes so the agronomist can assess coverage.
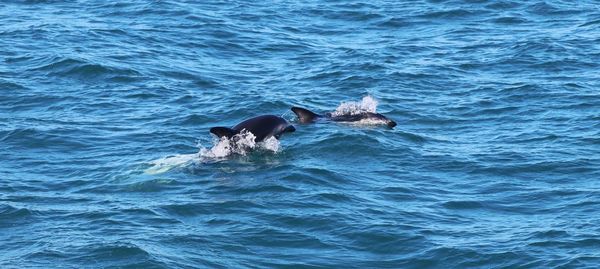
[292,107,396,128]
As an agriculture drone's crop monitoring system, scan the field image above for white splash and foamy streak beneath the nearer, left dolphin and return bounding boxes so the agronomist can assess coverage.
[144,130,280,174]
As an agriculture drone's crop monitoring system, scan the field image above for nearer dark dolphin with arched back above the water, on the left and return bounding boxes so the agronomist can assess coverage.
[210,115,296,142]
